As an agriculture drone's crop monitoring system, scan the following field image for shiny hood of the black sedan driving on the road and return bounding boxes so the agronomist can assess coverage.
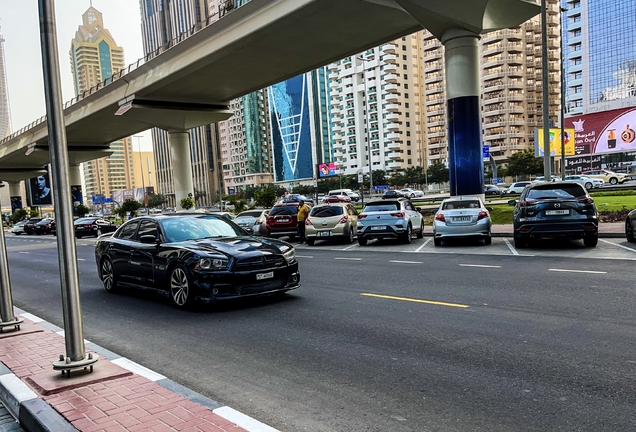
[178,236,293,256]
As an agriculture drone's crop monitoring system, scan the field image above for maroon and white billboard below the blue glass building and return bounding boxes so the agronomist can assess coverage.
[565,107,636,155]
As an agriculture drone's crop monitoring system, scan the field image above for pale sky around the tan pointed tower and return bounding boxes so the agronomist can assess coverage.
[0,0,152,151]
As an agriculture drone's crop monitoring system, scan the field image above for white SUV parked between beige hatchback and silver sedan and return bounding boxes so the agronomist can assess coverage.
[356,198,424,246]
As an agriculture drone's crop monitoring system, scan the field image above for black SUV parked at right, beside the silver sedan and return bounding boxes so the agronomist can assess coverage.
[509,181,598,248]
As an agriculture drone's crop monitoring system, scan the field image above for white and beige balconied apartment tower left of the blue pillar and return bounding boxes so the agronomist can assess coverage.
[328,32,426,175]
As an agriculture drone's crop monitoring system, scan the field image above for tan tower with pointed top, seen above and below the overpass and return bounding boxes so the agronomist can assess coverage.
[70,6,134,197]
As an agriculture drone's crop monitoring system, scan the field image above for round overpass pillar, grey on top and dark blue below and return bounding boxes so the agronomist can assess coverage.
[441,28,484,197]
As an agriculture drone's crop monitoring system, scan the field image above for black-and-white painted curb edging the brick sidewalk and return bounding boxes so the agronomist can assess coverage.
[0,307,280,432]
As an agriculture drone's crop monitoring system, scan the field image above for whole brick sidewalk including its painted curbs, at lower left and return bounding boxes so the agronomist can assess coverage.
[0,308,276,432]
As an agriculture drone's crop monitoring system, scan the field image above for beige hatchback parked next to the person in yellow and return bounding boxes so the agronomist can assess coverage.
[305,202,358,246]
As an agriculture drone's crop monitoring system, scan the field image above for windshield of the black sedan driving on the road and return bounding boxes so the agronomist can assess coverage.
[161,216,246,243]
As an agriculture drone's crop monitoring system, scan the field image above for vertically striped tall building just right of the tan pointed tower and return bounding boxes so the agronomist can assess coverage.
[139,0,223,206]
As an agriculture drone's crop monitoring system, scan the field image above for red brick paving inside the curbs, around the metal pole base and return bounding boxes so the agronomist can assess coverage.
[0,320,245,432]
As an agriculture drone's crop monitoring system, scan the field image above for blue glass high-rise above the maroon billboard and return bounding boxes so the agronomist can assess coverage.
[561,0,636,117]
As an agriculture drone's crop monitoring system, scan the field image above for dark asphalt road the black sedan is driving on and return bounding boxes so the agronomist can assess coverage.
[7,236,636,432]
